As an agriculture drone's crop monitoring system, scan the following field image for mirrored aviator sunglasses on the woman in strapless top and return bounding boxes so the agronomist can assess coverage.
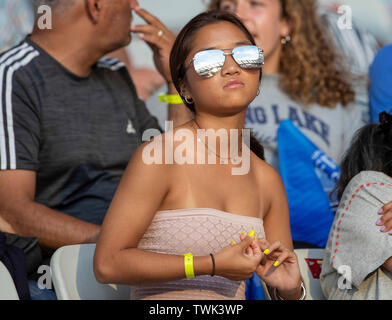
[188,45,264,78]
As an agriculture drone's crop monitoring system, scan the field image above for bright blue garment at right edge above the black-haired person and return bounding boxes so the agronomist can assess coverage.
[369,44,392,123]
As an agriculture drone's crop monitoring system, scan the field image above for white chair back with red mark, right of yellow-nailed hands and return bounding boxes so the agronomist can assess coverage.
[261,249,325,300]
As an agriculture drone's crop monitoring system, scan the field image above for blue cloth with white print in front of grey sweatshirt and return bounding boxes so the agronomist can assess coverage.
[278,120,340,248]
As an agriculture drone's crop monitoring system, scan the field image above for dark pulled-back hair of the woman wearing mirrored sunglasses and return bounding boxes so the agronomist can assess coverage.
[170,10,264,160]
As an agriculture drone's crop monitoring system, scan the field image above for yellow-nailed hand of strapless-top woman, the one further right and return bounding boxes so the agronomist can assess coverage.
[240,235,302,299]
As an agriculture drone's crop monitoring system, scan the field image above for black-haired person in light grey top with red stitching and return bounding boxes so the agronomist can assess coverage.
[320,112,392,300]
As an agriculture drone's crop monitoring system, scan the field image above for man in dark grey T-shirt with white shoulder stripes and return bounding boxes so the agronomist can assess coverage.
[0,0,180,298]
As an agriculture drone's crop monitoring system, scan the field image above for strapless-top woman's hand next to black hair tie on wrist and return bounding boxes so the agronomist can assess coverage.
[214,236,262,281]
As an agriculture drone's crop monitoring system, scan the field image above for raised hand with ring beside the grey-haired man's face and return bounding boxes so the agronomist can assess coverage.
[131,8,176,84]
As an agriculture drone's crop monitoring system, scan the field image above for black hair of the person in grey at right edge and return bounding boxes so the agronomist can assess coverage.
[335,112,392,200]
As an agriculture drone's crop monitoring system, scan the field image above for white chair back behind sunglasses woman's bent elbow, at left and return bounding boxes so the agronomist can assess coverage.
[50,244,131,300]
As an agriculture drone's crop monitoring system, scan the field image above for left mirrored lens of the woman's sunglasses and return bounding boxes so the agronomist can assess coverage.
[193,50,225,78]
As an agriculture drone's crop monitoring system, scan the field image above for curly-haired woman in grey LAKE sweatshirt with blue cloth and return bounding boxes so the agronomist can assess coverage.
[210,0,369,248]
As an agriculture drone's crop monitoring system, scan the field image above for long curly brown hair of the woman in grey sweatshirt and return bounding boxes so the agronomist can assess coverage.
[209,0,355,108]
